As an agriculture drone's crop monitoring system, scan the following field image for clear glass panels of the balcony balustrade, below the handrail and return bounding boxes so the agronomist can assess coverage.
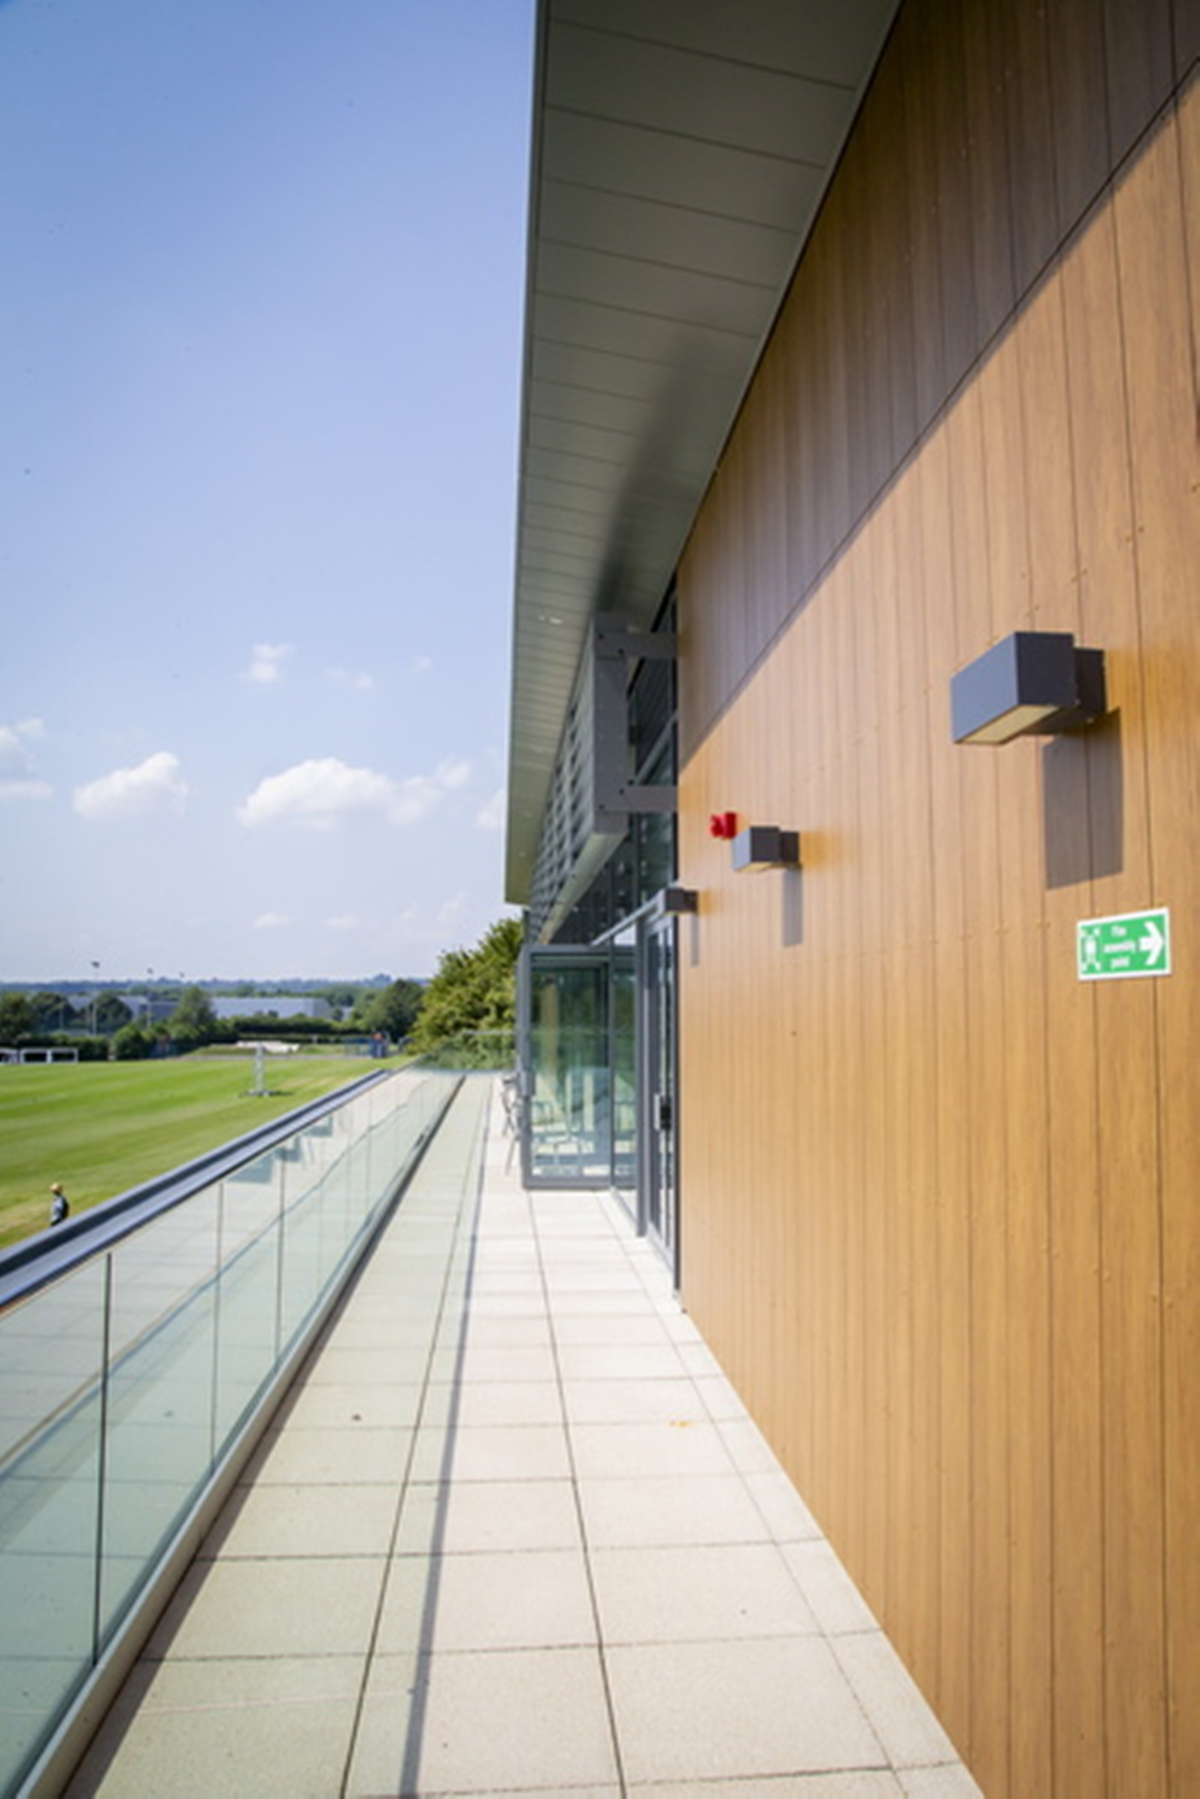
[0,1058,462,1794]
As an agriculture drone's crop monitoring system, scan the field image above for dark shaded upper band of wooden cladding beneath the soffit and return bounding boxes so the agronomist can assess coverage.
[682,0,1200,766]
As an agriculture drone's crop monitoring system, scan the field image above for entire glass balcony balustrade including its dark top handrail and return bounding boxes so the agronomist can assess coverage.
[0,1058,462,1795]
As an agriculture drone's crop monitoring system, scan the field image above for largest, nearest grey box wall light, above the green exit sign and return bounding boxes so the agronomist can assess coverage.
[950,631,1105,743]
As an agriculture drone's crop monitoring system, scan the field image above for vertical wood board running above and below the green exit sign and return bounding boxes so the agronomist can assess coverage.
[1067,193,1164,1792]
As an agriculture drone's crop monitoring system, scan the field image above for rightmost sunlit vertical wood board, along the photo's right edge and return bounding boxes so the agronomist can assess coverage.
[1112,90,1200,1792]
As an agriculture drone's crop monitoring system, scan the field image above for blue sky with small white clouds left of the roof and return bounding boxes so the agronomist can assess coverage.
[0,0,533,984]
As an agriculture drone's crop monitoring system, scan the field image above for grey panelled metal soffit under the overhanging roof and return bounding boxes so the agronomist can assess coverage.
[506,0,898,903]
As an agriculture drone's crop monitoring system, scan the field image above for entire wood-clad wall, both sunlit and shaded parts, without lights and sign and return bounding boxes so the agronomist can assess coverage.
[680,0,1200,1799]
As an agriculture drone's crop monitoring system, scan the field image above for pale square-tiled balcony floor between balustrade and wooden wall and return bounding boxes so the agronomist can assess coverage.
[68,1078,977,1799]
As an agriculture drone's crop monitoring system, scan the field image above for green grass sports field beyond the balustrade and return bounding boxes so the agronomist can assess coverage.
[0,1052,394,1245]
